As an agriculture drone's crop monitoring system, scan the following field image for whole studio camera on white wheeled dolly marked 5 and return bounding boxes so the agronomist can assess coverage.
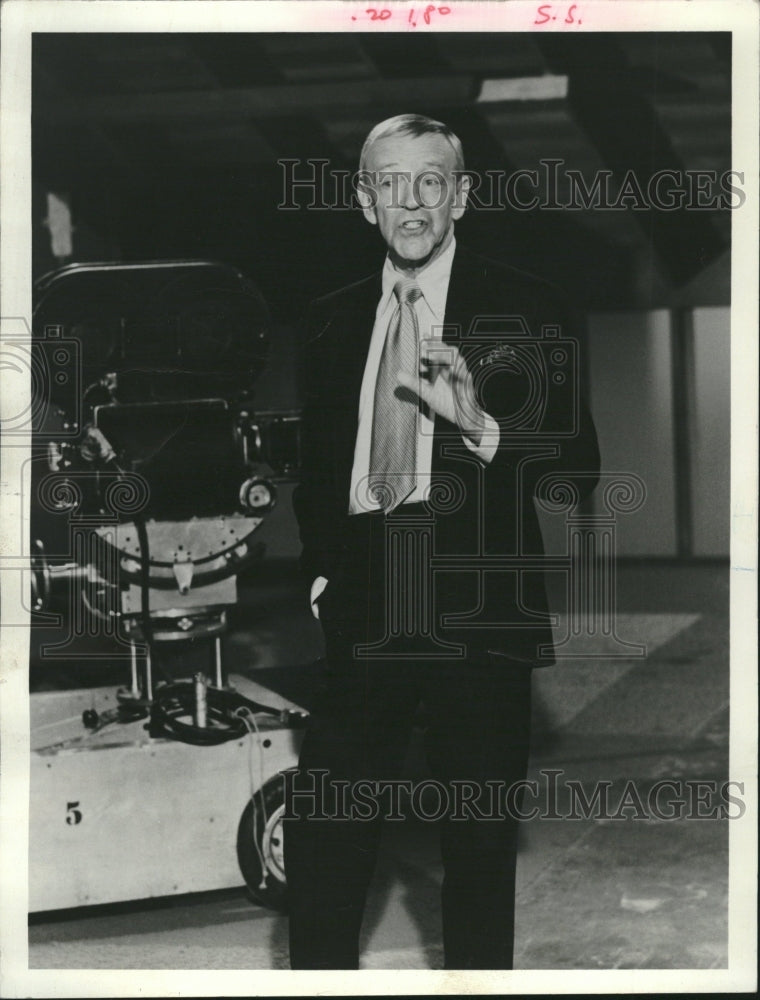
[30,261,305,911]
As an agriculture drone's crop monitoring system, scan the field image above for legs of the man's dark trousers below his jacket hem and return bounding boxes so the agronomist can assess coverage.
[284,629,531,969]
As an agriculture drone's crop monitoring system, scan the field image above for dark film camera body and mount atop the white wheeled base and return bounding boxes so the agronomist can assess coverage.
[29,261,300,686]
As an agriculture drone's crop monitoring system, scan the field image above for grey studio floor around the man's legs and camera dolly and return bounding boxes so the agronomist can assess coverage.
[29,564,730,969]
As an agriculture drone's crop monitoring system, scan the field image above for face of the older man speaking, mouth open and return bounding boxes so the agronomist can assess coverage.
[364,134,467,271]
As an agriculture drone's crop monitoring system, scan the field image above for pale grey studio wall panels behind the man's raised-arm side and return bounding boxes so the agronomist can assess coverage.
[588,307,730,558]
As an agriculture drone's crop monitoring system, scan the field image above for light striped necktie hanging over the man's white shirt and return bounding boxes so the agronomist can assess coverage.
[369,278,422,511]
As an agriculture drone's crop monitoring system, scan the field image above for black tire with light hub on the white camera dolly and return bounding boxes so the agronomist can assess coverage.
[237,775,288,911]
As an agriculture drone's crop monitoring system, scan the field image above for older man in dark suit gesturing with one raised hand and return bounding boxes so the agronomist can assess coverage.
[285,115,599,969]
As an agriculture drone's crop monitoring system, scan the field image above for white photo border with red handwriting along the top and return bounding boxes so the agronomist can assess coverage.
[0,0,760,997]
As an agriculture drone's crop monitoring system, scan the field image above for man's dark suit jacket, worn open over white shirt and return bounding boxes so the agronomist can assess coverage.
[294,246,599,663]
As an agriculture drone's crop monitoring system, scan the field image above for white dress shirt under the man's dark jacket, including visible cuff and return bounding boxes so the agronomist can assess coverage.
[348,239,499,514]
